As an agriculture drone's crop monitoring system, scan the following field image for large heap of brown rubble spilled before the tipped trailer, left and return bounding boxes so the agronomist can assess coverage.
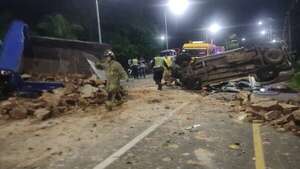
[0,75,107,120]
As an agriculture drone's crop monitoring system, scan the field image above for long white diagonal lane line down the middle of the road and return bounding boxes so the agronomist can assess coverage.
[94,103,189,169]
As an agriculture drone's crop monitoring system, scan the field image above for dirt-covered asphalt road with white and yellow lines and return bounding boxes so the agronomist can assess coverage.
[0,79,300,169]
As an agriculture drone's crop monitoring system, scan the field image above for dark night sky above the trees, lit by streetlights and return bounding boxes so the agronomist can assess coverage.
[0,0,290,46]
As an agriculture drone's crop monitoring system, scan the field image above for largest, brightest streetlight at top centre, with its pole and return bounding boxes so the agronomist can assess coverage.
[164,0,189,49]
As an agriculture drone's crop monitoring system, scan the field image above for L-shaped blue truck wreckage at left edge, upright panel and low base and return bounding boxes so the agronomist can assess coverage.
[0,21,63,97]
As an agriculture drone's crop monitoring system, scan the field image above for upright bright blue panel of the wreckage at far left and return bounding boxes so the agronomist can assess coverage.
[0,21,27,72]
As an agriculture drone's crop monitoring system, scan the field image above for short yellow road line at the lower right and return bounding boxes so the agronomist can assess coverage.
[253,123,266,169]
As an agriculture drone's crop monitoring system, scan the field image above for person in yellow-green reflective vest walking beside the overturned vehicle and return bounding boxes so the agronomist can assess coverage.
[152,56,164,90]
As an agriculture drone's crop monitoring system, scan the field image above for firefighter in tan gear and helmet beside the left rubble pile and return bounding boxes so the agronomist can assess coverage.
[97,50,128,111]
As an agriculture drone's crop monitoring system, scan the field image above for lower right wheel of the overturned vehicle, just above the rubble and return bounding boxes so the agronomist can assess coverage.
[255,68,279,82]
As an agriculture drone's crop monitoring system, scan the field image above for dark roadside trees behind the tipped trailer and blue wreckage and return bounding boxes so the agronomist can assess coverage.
[0,12,163,66]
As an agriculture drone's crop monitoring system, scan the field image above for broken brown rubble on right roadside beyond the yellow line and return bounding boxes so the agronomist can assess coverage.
[233,92,300,135]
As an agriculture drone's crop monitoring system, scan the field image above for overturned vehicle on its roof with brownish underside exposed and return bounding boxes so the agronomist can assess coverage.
[174,43,292,90]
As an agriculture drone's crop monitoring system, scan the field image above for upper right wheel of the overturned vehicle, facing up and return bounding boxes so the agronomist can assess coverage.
[263,49,284,65]
